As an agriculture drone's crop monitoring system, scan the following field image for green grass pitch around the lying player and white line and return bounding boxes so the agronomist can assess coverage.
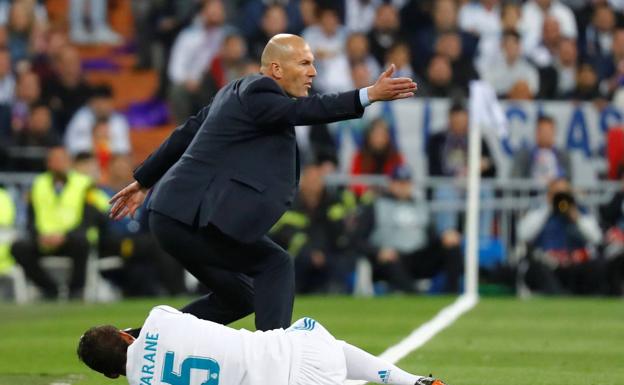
[0,297,624,385]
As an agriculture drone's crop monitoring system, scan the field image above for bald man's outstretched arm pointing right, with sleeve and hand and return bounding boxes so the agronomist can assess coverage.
[243,66,416,126]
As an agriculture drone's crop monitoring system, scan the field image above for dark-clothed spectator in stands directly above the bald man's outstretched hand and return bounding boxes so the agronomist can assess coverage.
[368,3,402,64]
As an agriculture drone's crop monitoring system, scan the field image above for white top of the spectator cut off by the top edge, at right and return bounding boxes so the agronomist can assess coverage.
[518,0,578,52]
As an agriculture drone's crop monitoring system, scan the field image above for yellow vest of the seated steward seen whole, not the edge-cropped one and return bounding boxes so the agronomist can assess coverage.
[31,172,93,235]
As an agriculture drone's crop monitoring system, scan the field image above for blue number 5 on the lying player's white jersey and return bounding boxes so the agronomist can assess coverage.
[161,352,219,385]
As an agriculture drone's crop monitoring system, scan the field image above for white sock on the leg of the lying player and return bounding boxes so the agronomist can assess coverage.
[342,341,421,385]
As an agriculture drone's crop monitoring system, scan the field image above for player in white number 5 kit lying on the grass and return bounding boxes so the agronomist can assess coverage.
[78,306,444,385]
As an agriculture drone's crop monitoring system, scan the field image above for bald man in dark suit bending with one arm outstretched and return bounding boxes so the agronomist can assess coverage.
[110,34,416,330]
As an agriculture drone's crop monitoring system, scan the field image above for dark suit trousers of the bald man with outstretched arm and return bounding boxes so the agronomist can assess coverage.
[149,211,295,330]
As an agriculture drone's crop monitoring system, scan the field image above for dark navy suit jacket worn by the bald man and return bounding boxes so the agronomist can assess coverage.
[134,74,364,243]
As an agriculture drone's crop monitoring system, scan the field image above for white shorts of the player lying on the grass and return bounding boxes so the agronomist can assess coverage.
[286,317,347,385]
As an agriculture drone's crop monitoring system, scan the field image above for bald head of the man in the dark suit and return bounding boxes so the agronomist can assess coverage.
[260,33,316,97]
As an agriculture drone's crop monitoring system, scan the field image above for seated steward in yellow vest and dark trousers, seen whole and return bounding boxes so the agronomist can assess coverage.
[12,146,99,299]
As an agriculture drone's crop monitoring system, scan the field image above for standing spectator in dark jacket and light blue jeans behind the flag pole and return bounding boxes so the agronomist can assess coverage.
[427,102,496,236]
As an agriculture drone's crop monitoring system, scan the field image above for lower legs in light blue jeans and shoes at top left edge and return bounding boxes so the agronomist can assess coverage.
[69,0,123,44]
